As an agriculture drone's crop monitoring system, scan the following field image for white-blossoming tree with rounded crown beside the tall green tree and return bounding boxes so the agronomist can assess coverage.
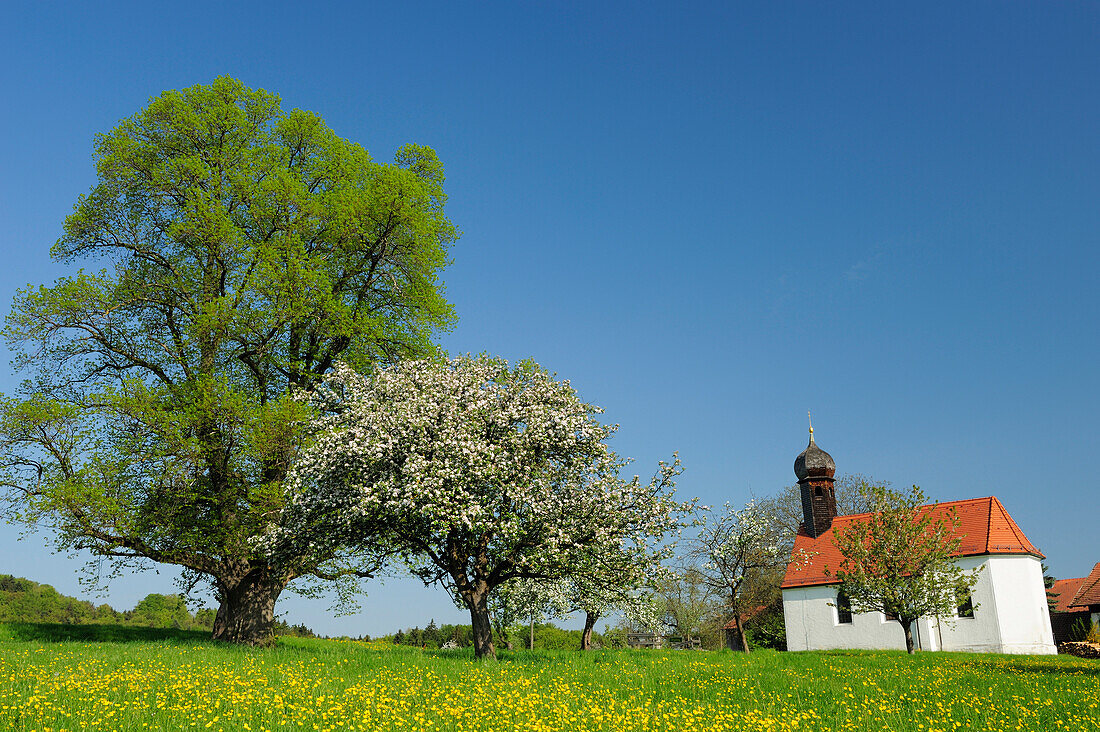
[272,357,694,658]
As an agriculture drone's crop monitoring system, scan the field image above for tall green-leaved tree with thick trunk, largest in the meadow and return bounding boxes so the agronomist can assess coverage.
[0,77,457,643]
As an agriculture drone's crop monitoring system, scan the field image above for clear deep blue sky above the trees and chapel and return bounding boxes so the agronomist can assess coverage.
[0,2,1100,635]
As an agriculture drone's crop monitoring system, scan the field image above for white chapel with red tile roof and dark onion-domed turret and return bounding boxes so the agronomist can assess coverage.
[781,428,1056,654]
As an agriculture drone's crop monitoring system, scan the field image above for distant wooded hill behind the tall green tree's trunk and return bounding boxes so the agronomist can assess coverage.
[0,575,314,637]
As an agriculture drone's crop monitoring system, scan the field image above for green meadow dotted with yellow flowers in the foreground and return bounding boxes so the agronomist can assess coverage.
[0,625,1100,732]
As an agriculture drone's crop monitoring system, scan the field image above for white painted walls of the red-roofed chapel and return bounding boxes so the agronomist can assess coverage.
[783,555,1057,654]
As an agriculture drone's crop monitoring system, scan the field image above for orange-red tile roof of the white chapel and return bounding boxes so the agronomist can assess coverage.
[780,496,1038,590]
